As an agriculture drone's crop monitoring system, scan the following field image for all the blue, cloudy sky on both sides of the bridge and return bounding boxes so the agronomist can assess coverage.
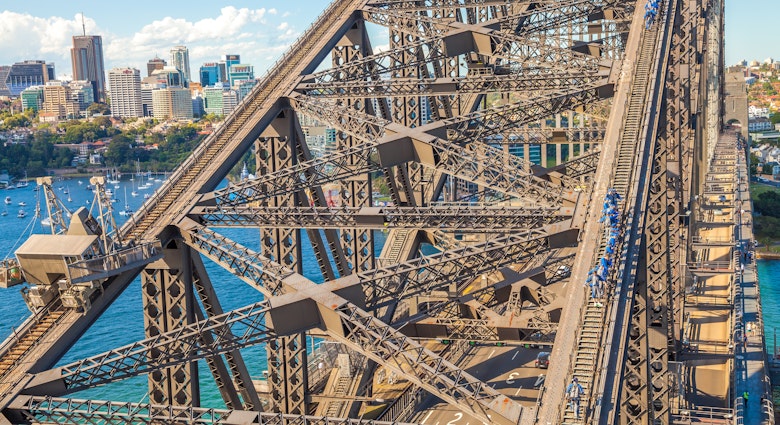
[0,0,780,78]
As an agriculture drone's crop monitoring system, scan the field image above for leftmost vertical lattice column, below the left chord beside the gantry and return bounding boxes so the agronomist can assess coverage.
[141,241,200,406]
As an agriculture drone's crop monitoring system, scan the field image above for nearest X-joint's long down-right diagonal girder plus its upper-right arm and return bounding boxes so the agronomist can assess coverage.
[184,228,532,423]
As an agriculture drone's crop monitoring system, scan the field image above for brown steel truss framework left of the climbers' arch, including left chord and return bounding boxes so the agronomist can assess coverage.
[3,0,676,424]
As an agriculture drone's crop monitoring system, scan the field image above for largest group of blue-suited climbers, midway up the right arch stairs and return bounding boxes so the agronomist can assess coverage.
[585,189,621,307]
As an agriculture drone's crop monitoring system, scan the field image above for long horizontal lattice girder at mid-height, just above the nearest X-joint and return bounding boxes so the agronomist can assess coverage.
[191,203,571,233]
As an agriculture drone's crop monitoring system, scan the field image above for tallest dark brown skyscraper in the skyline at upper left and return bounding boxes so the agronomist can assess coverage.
[70,35,106,102]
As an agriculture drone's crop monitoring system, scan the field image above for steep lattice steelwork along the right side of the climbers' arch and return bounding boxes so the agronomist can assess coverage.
[621,0,680,425]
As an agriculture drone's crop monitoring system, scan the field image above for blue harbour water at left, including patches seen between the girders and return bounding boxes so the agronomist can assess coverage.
[0,176,384,408]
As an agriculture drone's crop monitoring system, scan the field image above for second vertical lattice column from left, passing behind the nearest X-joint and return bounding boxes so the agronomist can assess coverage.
[255,109,308,414]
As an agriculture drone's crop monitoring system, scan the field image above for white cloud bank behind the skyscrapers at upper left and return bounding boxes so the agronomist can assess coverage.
[0,6,299,80]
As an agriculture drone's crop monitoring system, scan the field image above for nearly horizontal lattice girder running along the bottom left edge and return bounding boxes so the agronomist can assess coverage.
[8,396,411,425]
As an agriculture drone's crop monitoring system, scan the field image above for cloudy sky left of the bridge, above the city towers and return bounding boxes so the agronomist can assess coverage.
[0,0,329,80]
